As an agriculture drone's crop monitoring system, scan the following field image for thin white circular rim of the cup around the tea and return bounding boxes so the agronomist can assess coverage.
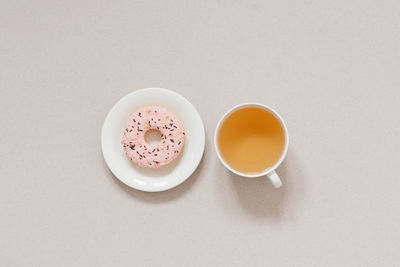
[214,102,289,178]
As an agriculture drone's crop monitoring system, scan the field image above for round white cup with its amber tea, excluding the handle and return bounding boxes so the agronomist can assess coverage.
[214,103,289,183]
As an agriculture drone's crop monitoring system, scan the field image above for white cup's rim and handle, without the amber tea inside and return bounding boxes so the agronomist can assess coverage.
[214,103,289,188]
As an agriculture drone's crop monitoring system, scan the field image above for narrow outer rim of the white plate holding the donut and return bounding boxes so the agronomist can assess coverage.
[100,87,205,192]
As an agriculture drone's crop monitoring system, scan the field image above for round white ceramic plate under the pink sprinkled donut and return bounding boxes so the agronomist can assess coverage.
[101,88,205,192]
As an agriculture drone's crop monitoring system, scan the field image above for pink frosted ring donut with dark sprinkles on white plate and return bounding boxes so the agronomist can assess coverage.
[122,106,185,168]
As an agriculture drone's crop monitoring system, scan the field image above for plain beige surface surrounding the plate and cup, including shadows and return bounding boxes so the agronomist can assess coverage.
[0,0,400,266]
